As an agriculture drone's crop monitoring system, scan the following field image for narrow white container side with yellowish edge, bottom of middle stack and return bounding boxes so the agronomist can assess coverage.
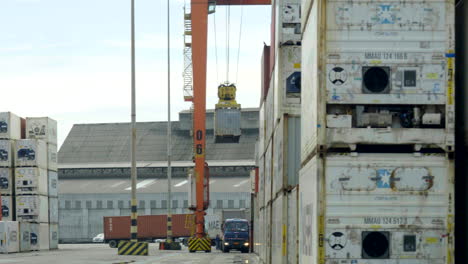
[269,194,288,264]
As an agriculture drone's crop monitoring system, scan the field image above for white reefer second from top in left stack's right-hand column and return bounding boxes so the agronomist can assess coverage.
[15,139,47,169]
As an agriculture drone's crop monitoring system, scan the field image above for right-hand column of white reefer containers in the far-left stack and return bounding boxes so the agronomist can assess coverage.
[15,117,58,250]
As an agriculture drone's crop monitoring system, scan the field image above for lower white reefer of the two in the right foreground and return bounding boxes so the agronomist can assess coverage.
[299,153,454,264]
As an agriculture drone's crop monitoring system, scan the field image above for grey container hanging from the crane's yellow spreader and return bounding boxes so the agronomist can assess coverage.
[214,107,241,143]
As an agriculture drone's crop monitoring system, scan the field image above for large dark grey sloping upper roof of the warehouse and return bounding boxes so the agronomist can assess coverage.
[58,113,258,165]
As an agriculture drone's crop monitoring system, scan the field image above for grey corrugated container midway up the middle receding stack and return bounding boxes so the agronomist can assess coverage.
[272,115,301,197]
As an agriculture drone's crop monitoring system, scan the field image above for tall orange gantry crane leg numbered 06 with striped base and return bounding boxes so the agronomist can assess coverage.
[184,0,271,252]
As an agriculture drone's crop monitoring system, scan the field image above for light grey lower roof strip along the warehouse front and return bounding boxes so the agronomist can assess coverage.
[59,177,250,194]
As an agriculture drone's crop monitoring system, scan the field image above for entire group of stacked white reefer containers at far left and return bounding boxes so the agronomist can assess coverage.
[0,113,58,253]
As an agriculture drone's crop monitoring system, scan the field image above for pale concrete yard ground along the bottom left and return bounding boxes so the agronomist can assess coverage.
[0,243,259,264]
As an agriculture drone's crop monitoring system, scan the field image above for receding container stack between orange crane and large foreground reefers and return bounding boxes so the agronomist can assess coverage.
[254,0,301,264]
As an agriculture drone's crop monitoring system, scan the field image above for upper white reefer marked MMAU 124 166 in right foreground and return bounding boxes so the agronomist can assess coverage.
[301,0,455,162]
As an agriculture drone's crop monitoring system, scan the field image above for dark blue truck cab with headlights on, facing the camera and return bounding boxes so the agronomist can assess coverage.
[221,219,250,253]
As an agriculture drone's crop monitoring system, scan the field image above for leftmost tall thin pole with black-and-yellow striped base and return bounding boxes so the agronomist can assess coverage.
[130,0,138,242]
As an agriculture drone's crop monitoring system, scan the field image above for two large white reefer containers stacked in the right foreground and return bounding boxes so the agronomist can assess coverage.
[299,0,455,264]
